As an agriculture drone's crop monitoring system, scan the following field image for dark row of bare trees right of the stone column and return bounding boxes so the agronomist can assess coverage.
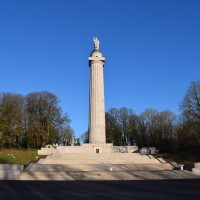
[106,81,200,151]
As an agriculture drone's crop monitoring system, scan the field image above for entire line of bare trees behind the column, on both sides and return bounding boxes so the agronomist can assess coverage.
[0,81,200,151]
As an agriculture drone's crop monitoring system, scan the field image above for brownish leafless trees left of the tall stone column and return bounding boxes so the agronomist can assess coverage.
[0,91,74,148]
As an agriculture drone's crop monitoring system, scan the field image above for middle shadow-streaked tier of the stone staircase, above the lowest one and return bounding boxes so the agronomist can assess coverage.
[25,163,173,172]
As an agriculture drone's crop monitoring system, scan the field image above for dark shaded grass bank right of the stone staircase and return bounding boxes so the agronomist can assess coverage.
[155,150,200,165]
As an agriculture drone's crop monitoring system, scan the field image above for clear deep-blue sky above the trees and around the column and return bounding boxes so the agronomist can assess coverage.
[0,0,200,136]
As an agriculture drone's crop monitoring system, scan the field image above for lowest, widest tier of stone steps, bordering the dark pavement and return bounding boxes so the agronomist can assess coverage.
[17,170,199,181]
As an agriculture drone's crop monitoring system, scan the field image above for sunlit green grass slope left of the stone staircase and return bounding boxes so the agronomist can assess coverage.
[0,148,38,165]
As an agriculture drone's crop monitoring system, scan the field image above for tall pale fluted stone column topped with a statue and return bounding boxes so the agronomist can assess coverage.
[89,37,106,144]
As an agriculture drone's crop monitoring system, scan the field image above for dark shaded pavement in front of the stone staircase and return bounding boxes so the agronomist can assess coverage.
[0,179,200,200]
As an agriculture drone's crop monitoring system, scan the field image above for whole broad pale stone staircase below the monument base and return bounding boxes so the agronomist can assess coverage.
[17,152,199,181]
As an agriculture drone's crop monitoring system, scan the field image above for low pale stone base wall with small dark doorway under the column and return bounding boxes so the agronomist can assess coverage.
[38,143,138,155]
